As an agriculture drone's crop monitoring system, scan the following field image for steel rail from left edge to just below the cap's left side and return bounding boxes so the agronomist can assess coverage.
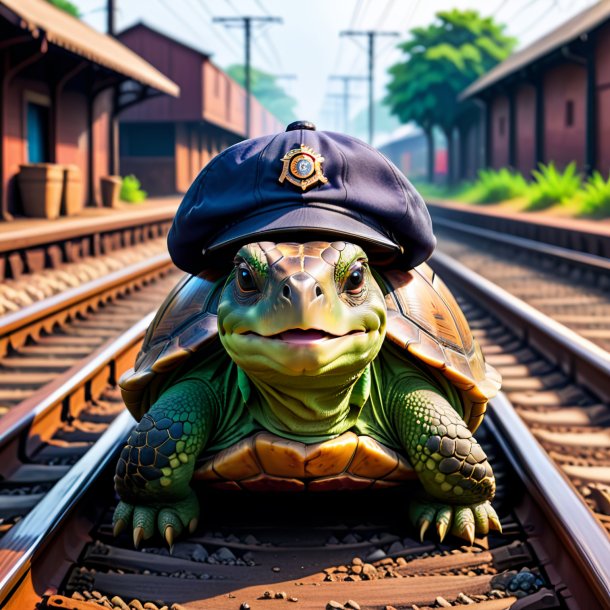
[0,253,172,341]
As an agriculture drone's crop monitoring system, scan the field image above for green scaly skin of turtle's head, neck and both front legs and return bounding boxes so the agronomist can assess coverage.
[114,242,500,547]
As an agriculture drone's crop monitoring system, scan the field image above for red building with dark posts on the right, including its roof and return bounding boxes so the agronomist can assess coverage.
[458,0,610,178]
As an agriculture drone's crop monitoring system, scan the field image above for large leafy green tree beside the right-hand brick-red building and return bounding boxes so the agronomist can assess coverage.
[385,9,516,181]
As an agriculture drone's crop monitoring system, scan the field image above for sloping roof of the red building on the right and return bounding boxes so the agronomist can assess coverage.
[460,0,610,100]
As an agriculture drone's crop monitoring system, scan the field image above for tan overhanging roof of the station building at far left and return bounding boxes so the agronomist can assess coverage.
[0,0,180,97]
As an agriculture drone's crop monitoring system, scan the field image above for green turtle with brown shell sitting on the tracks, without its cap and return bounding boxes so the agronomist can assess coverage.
[113,241,501,547]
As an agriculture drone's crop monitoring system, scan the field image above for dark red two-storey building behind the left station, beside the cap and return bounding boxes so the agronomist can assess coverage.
[119,23,284,195]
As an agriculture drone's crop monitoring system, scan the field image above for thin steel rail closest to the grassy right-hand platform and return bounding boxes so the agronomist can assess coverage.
[433,218,610,273]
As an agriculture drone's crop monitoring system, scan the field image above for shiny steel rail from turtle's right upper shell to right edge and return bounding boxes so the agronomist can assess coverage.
[430,252,610,400]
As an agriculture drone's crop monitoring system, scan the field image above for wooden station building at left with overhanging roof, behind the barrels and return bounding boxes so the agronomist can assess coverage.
[0,0,179,219]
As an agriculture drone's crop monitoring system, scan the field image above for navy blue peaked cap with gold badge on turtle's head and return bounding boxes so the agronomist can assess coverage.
[168,121,436,274]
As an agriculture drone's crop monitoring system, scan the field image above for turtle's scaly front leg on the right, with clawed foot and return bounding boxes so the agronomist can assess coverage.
[395,388,501,544]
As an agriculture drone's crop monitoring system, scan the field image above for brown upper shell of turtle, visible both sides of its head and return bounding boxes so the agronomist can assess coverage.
[119,264,501,432]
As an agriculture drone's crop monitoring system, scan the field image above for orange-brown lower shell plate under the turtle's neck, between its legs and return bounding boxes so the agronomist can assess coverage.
[193,432,417,491]
